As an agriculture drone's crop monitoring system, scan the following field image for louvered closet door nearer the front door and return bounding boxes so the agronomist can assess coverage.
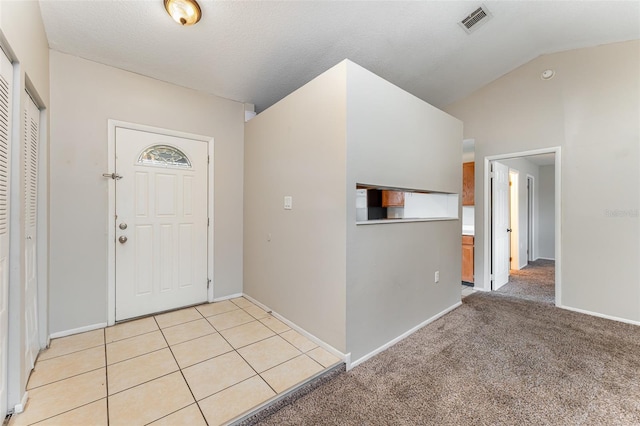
[23,91,40,371]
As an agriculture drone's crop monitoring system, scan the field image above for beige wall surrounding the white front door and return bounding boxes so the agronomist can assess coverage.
[50,51,244,333]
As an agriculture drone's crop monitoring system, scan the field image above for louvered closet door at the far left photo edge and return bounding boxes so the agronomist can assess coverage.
[0,50,13,420]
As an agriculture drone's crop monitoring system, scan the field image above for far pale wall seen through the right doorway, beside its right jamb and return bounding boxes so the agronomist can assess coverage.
[536,166,556,259]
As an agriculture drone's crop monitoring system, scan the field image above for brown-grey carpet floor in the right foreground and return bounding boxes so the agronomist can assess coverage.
[255,293,640,425]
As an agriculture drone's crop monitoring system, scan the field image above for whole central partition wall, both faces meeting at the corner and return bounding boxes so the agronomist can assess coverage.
[244,61,462,361]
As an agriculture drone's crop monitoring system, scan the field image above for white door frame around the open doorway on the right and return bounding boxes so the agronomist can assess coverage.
[478,146,562,306]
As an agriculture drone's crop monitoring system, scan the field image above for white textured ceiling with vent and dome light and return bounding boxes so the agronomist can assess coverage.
[40,0,640,111]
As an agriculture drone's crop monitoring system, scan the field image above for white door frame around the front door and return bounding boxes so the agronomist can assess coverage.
[106,119,215,325]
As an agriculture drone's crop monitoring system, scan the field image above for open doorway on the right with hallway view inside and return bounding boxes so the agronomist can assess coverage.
[485,149,560,305]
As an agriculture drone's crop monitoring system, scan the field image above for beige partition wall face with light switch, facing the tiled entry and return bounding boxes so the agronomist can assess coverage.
[244,63,347,352]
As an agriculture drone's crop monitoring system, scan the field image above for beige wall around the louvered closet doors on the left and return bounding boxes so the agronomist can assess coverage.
[0,1,49,408]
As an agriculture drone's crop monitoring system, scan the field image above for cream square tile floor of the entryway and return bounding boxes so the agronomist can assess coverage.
[9,298,340,426]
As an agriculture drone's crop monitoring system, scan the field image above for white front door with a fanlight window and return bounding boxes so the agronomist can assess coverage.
[114,127,208,321]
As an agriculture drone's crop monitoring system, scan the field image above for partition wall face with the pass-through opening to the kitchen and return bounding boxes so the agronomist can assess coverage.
[346,62,462,362]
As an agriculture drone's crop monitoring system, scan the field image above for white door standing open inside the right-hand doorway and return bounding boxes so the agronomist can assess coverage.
[491,161,510,290]
